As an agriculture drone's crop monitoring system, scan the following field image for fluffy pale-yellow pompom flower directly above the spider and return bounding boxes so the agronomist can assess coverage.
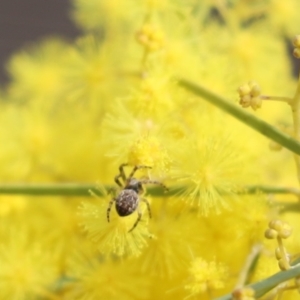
[101,100,171,174]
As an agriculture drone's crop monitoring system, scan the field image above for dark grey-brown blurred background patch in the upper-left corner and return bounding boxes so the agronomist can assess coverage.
[0,0,79,86]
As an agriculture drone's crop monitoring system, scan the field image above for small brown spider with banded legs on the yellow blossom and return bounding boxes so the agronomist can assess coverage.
[107,164,168,232]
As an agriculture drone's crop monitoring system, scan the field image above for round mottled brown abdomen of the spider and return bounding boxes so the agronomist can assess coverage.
[116,189,139,217]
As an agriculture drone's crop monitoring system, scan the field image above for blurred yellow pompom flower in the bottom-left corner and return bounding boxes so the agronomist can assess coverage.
[0,226,59,299]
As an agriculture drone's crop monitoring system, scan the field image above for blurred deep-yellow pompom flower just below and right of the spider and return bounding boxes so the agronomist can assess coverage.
[134,198,205,278]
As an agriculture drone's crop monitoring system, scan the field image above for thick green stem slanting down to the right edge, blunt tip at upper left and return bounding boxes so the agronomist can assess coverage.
[177,78,300,155]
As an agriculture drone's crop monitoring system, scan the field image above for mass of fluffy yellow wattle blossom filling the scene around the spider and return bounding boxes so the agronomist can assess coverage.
[0,0,300,300]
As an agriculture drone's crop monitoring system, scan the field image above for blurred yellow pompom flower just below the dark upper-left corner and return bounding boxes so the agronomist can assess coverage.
[8,39,69,106]
